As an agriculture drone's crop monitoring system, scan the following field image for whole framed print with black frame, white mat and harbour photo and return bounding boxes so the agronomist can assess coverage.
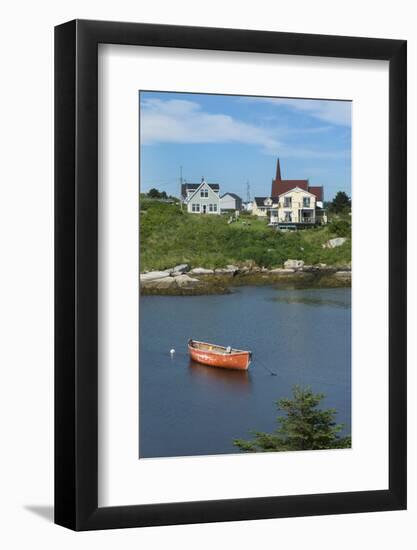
[55,20,406,530]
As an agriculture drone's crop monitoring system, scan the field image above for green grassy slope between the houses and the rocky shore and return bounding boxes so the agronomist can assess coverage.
[140,199,351,271]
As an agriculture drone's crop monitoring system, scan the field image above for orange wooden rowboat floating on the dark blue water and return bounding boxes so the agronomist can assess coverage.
[188,340,252,370]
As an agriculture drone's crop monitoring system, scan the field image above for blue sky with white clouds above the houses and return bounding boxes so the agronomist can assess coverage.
[139,92,351,200]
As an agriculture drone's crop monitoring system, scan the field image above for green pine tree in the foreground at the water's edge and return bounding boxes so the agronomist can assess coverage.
[233,386,351,452]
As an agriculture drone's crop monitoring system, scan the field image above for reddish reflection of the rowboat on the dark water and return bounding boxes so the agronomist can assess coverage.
[189,359,251,393]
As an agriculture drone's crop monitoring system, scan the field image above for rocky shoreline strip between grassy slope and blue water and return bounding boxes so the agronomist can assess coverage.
[140,259,352,296]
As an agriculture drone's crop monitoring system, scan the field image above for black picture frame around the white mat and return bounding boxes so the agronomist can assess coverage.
[55,20,407,531]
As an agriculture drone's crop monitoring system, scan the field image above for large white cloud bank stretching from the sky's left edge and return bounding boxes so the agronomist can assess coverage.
[140,99,345,158]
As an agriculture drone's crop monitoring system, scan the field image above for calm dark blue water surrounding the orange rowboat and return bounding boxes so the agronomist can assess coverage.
[139,287,351,458]
